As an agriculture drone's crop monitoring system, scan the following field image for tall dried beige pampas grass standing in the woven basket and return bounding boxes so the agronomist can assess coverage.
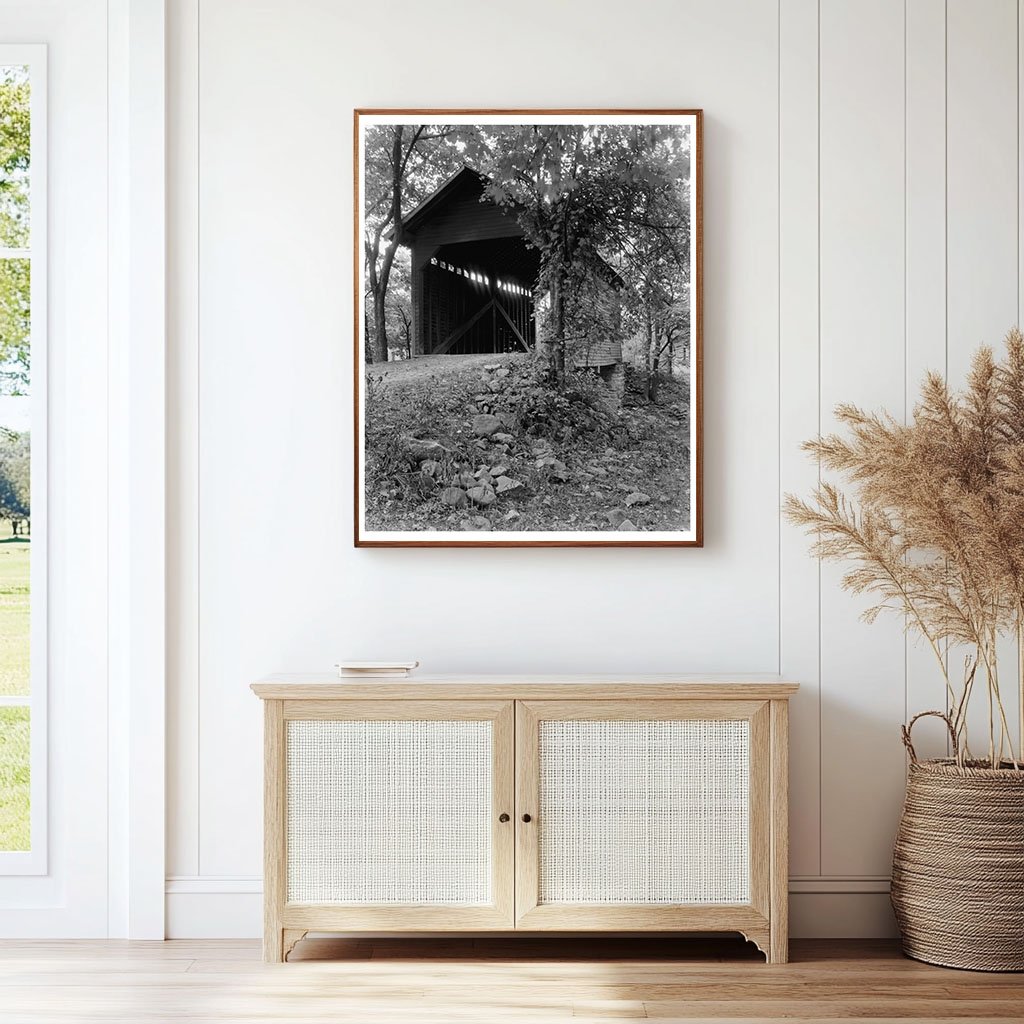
[784,328,1024,769]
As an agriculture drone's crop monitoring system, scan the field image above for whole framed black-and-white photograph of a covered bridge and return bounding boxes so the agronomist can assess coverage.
[354,110,702,547]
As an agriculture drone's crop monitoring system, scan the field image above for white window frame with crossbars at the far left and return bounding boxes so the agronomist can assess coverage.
[0,43,49,876]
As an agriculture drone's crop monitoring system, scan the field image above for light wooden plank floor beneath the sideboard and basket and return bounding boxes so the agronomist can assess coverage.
[0,936,1024,1024]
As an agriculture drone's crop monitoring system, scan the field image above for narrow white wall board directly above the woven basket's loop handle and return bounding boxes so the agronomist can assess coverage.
[894,0,946,757]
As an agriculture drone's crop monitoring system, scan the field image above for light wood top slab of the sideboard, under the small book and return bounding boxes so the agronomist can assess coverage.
[252,673,799,700]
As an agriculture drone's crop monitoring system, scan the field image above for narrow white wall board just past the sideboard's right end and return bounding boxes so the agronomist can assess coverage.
[778,0,821,876]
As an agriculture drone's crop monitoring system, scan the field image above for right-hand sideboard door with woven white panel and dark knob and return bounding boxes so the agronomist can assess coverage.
[516,700,769,938]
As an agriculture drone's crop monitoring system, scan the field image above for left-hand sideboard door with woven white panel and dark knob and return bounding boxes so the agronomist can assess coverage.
[279,700,514,931]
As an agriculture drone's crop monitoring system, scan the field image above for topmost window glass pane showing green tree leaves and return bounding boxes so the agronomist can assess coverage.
[0,66,31,249]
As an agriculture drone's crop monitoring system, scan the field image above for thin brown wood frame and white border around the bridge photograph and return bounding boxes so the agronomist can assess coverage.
[352,108,703,548]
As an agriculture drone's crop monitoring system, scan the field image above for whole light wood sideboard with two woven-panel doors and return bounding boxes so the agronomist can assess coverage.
[253,676,797,964]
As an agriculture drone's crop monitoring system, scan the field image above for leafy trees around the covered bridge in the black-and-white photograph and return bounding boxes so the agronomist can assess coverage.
[364,118,692,387]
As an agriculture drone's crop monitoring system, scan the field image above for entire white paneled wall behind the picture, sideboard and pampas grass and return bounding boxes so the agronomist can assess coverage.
[168,0,1022,935]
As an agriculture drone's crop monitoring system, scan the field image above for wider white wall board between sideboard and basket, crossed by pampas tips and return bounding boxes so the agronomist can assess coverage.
[819,0,905,874]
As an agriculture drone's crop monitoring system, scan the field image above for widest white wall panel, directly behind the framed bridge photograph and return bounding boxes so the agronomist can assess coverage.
[192,0,779,878]
